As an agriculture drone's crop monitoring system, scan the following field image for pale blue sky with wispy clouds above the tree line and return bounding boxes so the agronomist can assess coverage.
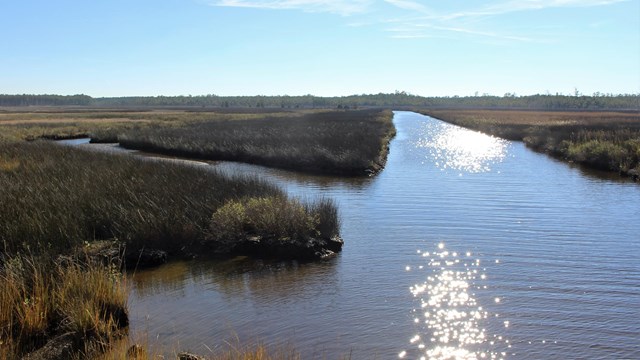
[0,0,640,97]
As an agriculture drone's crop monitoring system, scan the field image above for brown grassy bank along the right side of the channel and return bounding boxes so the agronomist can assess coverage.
[419,110,640,175]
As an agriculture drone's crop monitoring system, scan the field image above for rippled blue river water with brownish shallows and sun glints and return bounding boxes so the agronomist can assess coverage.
[129,112,640,359]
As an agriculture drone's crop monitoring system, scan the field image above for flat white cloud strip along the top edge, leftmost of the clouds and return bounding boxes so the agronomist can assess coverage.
[208,0,373,16]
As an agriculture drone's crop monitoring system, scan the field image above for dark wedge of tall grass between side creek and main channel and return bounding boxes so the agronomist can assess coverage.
[118,110,395,175]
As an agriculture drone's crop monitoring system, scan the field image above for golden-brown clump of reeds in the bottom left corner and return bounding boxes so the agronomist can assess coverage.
[0,256,128,359]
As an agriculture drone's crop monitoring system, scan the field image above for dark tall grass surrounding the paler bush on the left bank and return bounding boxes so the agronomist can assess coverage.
[0,141,338,253]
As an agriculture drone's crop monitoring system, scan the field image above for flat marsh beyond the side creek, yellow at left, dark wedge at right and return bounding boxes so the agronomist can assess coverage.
[0,109,395,175]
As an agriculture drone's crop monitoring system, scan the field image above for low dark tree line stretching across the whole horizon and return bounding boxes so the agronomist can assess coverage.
[0,91,640,110]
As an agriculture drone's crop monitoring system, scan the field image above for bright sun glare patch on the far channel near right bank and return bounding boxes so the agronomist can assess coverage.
[416,124,509,173]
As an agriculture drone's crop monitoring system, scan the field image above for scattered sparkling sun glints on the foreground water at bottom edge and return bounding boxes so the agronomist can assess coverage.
[398,243,509,359]
